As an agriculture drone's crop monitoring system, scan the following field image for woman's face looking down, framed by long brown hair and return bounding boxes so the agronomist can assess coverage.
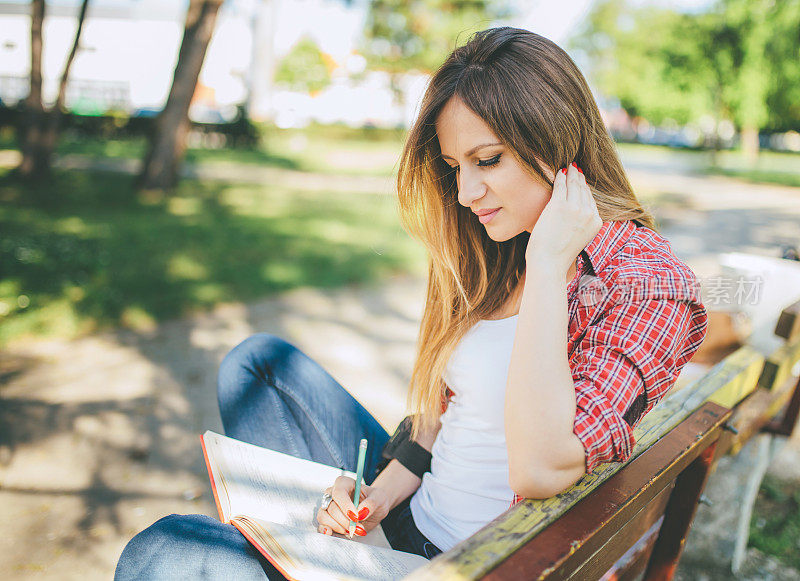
[436,97,555,242]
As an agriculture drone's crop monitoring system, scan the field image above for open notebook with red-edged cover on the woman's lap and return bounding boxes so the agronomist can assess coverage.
[201,431,428,581]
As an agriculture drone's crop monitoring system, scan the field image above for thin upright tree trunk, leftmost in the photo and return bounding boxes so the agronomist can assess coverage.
[16,0,48,179]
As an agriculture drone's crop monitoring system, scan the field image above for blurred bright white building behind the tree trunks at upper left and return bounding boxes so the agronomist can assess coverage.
[0,0,424,126]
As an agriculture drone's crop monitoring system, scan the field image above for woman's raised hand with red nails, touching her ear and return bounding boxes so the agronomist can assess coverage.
[525,165,603,272]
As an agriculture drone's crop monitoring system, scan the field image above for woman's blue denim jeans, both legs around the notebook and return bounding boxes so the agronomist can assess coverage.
[115,333,441,581]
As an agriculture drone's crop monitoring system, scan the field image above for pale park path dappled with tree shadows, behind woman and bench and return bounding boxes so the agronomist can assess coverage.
[0,152,800,580]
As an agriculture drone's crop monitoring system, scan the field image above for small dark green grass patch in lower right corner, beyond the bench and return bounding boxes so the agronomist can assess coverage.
[750,476,800,569]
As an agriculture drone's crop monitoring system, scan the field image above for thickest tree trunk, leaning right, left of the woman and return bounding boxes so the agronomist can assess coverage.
[137,0,222,190]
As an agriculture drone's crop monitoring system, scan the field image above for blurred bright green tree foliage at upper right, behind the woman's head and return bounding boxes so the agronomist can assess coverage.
[571,0,800,131]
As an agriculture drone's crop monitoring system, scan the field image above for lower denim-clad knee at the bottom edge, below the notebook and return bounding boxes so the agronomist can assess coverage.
[114,514,265,581]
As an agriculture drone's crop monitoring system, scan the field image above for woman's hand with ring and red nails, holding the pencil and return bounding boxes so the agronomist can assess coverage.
[317,476,391,537]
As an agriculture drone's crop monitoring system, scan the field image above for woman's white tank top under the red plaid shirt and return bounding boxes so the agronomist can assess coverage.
[411,315,518,551]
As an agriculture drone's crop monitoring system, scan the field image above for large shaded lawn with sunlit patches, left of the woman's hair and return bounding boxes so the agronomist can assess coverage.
[0,170,424,344]
